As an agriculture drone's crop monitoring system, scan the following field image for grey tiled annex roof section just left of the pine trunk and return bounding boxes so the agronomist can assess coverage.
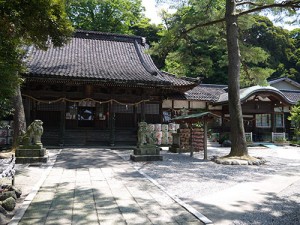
[185,84,227,102]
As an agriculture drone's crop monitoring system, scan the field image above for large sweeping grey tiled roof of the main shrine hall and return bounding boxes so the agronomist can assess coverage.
[25,31,196,87]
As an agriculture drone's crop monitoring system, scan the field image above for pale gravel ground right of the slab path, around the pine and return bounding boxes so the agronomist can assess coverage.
[118,146,300,225]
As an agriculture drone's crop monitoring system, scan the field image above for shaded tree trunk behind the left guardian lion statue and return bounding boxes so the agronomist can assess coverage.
[13,86,26,148]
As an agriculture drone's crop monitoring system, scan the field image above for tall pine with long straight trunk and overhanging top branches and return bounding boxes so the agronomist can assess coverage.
[156,0,300,158]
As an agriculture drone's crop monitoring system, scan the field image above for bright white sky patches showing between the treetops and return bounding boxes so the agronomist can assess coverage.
[142,0,299,30]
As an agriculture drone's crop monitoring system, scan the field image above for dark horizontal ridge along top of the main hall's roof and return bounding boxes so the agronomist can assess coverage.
[74,30,146,45]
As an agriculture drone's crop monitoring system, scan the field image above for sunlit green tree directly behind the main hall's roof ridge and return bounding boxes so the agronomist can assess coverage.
[66,0,164,68]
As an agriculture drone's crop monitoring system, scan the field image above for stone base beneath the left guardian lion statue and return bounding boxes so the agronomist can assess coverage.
[15,148,48,164]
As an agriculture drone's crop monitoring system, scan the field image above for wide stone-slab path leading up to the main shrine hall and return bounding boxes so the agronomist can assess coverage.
[10,148,203,225]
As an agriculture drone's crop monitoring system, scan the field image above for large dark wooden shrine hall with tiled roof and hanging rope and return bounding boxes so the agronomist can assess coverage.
[21,31,198,145]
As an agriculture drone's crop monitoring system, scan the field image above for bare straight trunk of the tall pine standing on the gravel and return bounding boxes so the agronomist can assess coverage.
[225,0,248,156]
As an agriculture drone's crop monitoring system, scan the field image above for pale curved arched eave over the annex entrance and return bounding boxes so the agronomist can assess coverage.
[214,86,295,105]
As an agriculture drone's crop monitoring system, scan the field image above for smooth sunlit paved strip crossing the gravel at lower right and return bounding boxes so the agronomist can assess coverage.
[190,175,300,225]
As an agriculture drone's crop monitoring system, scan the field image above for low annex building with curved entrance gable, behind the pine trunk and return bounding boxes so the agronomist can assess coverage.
[163,78,300,142]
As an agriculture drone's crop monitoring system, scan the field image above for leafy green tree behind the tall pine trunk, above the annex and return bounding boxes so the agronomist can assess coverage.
[152,7,274,86]
